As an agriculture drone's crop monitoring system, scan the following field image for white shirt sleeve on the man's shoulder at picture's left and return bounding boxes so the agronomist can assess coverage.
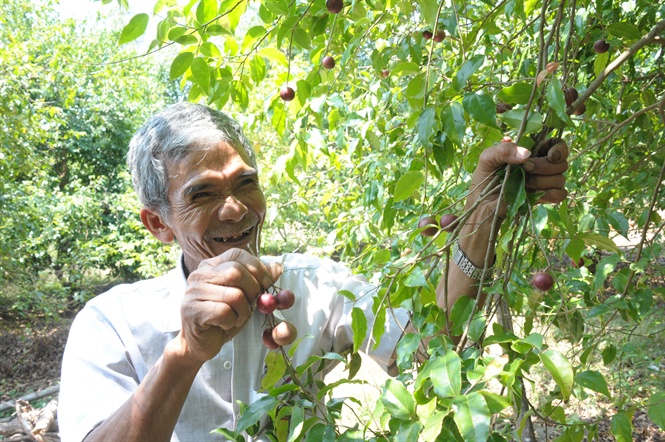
[58,298,139,442]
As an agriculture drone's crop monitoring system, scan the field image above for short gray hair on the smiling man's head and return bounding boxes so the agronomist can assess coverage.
[127,102,257,219]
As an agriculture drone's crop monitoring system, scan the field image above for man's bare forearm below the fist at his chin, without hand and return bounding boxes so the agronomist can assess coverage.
[85,338,201,442]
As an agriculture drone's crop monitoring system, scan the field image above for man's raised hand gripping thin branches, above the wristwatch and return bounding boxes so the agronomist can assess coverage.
[466,138,568,217]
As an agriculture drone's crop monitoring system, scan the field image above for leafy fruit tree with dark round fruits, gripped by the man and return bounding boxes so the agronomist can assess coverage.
[107,0,665,440]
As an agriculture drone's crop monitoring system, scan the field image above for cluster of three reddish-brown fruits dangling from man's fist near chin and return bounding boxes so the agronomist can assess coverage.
[256,289,298,350]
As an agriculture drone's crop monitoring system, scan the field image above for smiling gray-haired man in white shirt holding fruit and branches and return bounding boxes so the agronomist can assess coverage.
[59,103,568,442]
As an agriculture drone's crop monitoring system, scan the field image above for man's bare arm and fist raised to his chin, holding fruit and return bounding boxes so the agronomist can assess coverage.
[85,249,282,442]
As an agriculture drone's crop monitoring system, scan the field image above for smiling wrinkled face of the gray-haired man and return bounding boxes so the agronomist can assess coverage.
[165,142,266,272]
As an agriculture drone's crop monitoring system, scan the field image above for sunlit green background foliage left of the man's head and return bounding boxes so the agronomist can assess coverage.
[0,1,179,315]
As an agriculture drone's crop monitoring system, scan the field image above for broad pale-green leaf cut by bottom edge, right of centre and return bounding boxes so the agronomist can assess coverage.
[453,392,490,442]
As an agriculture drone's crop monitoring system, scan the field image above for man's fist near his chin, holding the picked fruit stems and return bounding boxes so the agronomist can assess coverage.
[180,249,282,363]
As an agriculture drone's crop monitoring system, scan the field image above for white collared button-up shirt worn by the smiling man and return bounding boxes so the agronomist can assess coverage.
[58,254,408,442]
